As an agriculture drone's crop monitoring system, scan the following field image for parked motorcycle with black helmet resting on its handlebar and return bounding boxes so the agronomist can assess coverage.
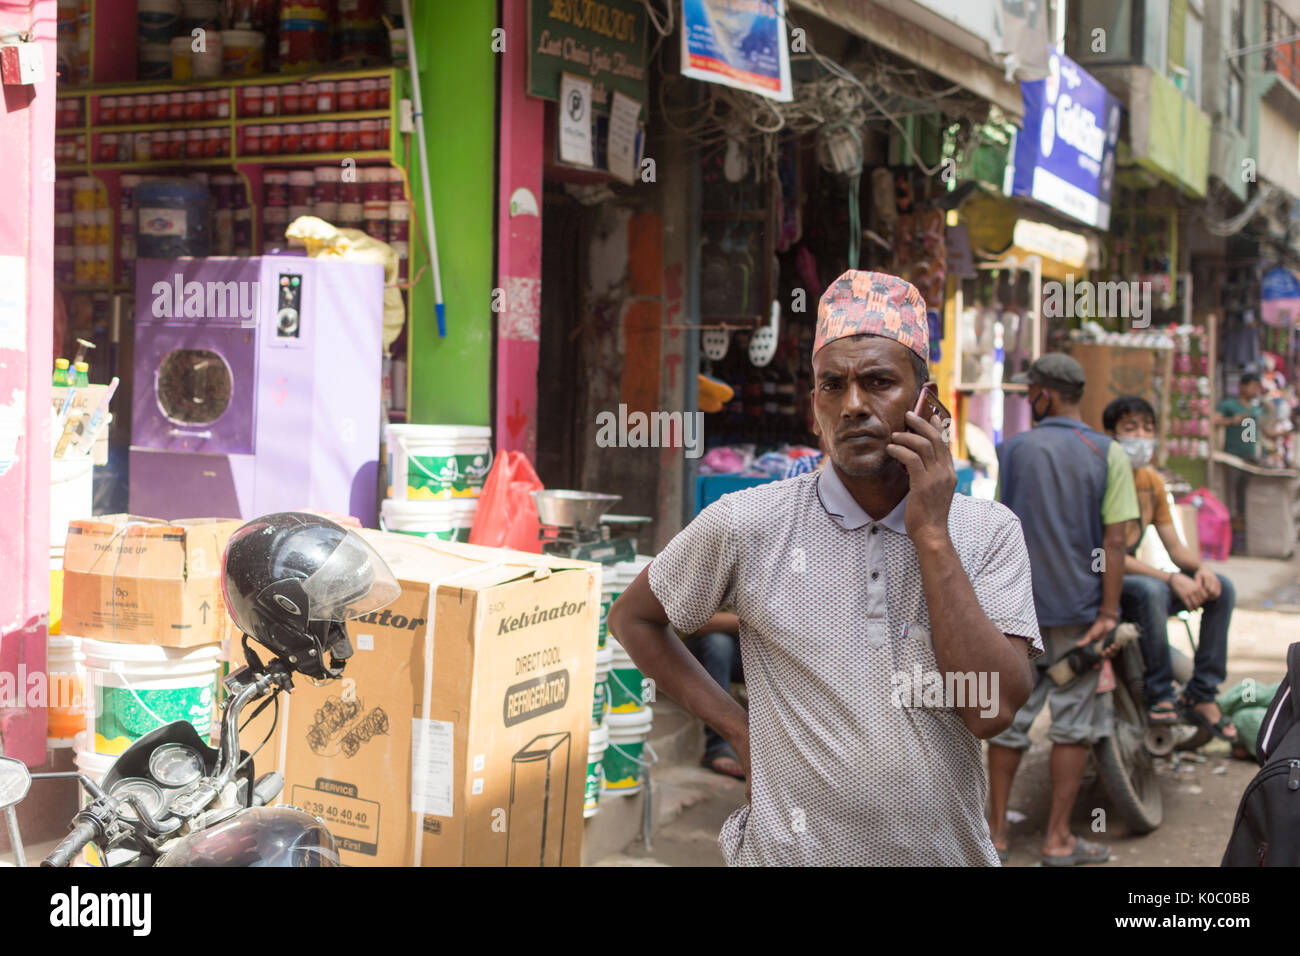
[0,512,400,866]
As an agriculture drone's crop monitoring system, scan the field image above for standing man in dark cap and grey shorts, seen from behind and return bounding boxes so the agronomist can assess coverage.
[988,352,1139,866]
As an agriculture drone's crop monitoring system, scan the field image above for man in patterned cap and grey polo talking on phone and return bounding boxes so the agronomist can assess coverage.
[610,269,1043,866]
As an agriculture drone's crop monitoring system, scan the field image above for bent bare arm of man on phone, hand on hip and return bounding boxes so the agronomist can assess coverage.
[608,580,749,779]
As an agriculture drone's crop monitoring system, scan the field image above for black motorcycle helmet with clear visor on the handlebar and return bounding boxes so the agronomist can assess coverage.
[221,511,402,680]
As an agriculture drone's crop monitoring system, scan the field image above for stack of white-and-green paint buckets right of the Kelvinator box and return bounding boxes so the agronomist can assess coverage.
[582,554,654,817]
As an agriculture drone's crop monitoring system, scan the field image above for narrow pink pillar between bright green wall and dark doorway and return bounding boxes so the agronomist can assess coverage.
[494,0,546,463]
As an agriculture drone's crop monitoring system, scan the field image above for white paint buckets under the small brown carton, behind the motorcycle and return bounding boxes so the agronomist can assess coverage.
[47,635,221,865]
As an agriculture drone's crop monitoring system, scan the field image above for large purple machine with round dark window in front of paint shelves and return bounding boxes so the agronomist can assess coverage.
[130,255,384,528]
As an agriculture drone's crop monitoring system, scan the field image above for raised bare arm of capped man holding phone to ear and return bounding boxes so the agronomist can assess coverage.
[887,412,1034,739]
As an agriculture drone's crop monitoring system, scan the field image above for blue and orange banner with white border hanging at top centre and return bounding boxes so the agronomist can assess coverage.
[681,0,793,103]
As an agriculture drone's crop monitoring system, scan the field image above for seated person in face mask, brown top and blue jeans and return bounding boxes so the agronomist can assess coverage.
[1101,395,1236,744]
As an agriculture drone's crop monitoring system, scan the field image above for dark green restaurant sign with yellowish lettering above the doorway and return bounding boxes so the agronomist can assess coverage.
[528,0,649,111]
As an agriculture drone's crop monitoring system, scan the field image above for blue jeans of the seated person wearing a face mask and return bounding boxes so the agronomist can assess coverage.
[1119,575,1236,706]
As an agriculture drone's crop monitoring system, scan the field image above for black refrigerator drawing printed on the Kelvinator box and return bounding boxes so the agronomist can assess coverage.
[506,732,571,866]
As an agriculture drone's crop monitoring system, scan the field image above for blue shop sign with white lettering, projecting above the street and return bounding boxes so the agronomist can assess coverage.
[1011,47,1119,229]
